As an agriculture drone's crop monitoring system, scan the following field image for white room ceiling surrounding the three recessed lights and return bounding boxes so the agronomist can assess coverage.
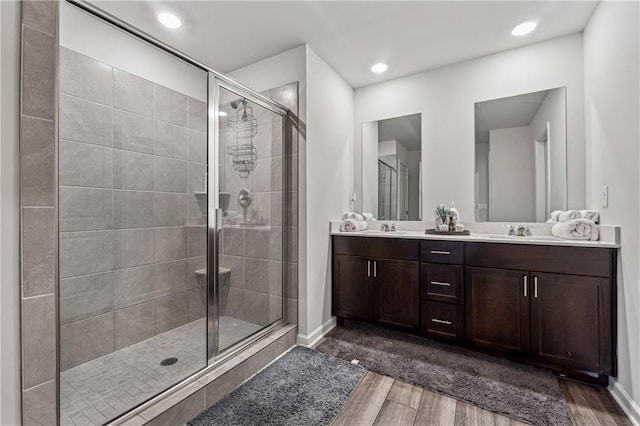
[87,0,597,87]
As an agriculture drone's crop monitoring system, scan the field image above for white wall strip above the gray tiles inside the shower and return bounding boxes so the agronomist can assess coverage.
[60,2,208,102]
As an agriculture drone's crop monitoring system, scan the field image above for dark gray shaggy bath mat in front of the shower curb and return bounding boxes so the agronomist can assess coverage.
[188,347,366,426]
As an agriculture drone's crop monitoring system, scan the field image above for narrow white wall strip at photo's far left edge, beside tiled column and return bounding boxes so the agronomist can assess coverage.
[0,1,20,425]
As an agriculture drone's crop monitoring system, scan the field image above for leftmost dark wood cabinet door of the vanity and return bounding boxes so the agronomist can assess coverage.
[333,256,373,321]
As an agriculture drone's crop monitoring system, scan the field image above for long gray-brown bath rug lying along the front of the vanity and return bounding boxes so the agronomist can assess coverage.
[317,321,572,426]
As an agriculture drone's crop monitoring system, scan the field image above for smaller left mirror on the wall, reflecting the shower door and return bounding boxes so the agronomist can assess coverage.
[362,114,422,220]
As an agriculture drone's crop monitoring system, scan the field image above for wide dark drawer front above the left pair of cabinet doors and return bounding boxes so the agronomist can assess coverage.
[333,236,420,261]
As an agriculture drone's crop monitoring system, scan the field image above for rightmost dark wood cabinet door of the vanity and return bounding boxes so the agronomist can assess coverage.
[531,273,611,373]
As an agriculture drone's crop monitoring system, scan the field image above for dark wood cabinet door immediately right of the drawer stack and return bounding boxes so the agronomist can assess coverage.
[465,267,530,354]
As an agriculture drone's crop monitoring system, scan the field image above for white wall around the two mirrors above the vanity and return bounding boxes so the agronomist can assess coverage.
[354,34,585,218]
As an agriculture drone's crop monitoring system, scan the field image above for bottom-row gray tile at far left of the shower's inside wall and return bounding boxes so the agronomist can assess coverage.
[60,312,114,371]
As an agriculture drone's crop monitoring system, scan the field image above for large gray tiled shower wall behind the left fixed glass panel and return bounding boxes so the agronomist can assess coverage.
[59,48,207,371]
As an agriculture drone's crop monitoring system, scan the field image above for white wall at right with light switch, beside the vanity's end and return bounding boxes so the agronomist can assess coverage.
[584,2,640,423]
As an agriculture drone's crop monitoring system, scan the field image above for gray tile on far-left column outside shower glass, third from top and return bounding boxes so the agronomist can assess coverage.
[20,116,55,206]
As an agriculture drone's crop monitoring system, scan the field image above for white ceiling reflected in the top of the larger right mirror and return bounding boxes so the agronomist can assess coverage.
[475,89,562,143]
